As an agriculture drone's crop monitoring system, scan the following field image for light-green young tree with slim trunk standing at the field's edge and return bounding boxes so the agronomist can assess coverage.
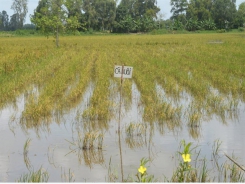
[31,0,81,47]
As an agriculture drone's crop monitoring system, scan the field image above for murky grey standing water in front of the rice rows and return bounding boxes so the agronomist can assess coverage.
[0,84,245,182]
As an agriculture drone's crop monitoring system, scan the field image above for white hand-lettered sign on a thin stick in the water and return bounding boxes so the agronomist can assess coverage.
[114,65,133,182]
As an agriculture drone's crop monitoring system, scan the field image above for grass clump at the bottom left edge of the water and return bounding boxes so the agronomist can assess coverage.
[16,168,49,183]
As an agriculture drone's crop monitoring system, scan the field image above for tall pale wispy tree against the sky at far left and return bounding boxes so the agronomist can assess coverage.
[11,0,28,28]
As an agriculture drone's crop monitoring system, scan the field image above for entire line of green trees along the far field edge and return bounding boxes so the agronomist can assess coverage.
[0,0,245,33]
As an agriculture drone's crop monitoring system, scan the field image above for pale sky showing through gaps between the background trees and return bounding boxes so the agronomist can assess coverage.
[0,0,245,24]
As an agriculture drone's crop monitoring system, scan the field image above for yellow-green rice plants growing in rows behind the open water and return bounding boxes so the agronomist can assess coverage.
[0,34,245,132]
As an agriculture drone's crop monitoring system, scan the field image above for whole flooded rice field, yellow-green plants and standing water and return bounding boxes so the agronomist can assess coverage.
[0,33,245,182]
